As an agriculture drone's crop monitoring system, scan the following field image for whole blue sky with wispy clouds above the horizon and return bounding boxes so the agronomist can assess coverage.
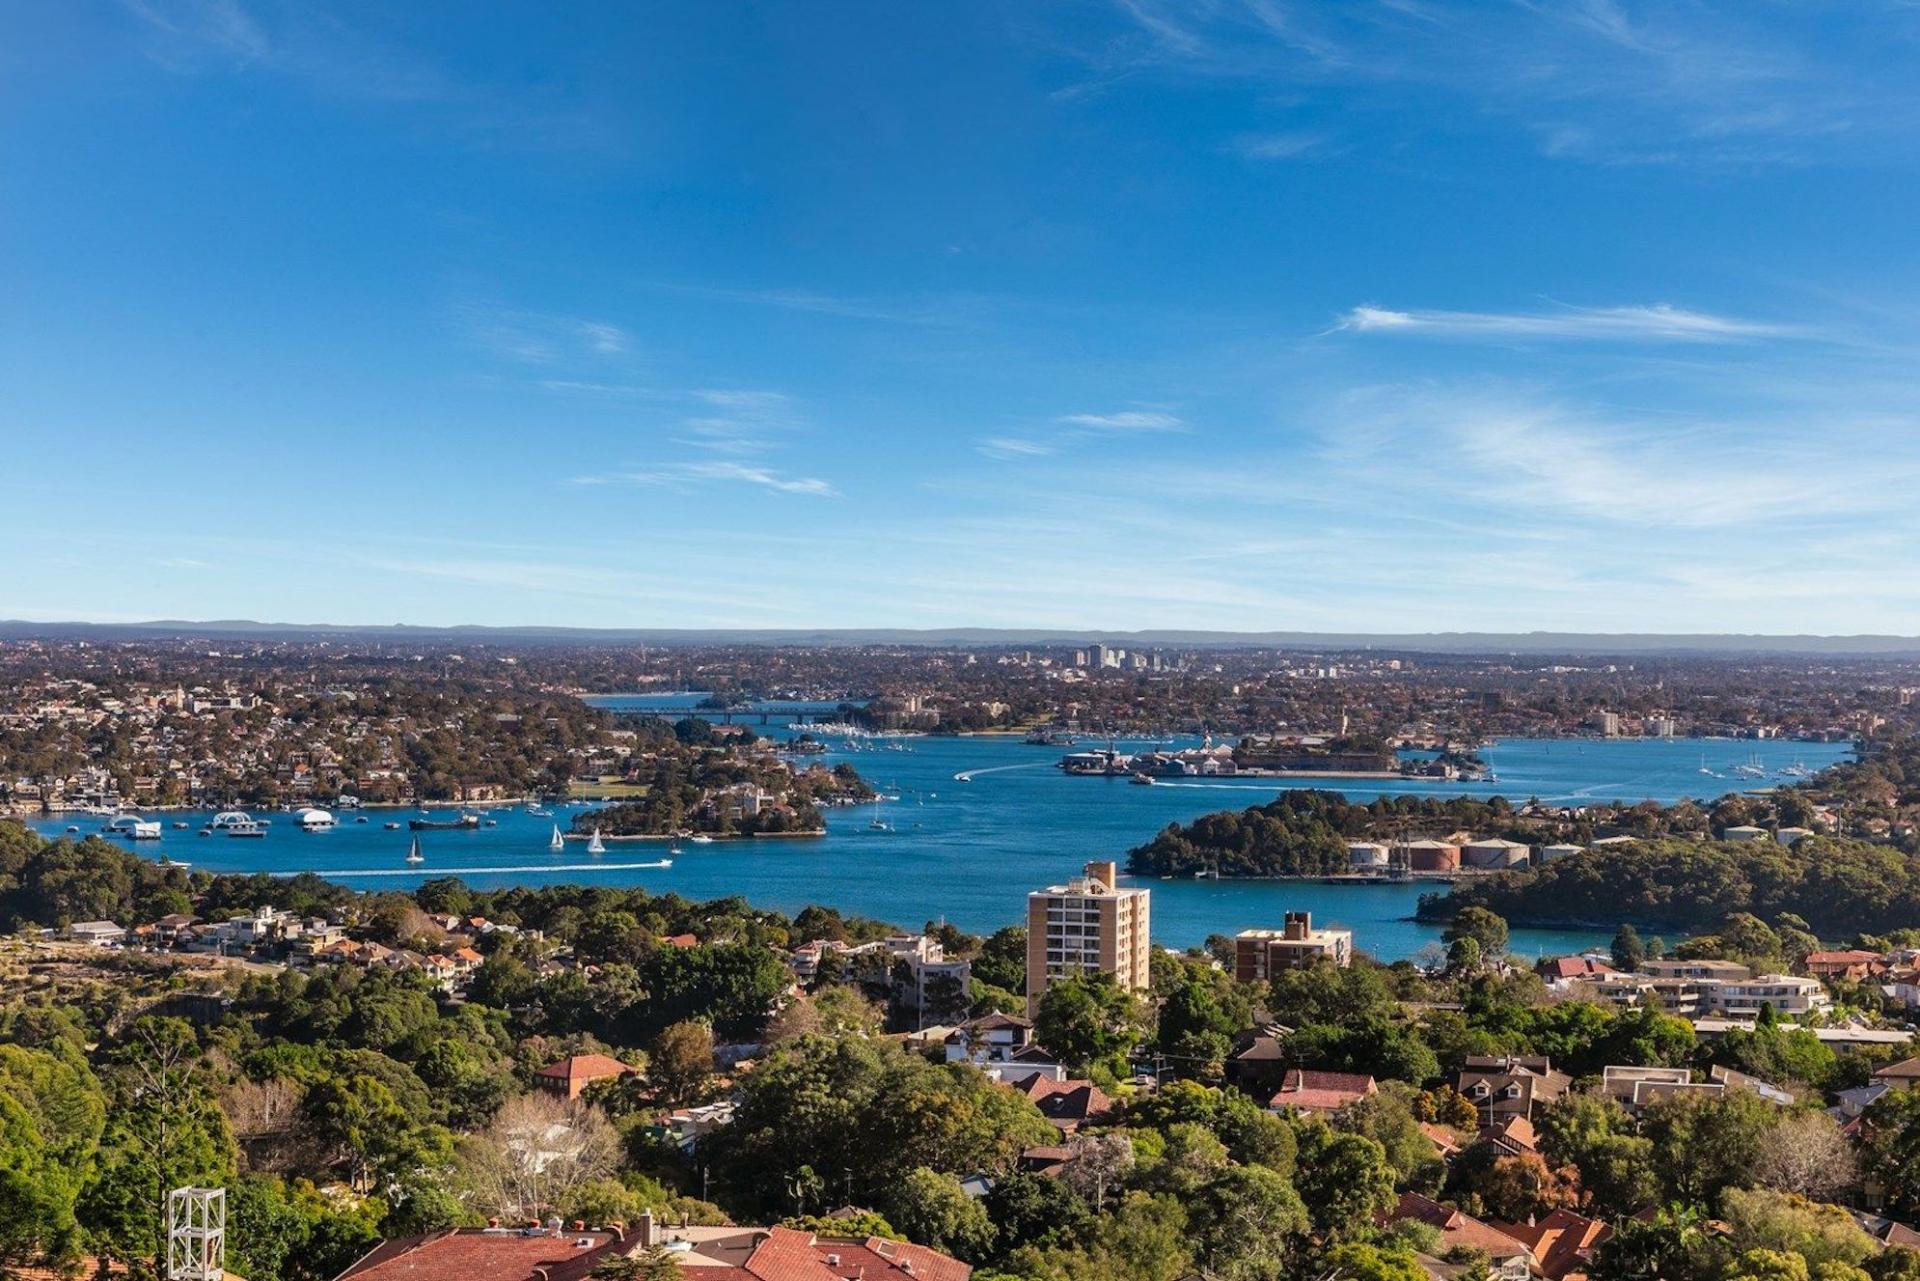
[0,0,1920,634]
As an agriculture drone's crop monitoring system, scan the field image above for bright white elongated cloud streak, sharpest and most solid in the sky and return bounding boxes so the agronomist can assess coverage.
[1334,303,1805,342]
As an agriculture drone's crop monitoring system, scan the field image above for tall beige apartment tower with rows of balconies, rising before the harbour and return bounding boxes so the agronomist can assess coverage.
[1027,862,1150,1014]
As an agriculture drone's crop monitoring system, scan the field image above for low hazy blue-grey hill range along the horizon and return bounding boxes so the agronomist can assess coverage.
[0,618,1920,657]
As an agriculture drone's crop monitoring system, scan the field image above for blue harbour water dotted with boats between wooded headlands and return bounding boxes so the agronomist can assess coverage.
[35,695,1849,960]
